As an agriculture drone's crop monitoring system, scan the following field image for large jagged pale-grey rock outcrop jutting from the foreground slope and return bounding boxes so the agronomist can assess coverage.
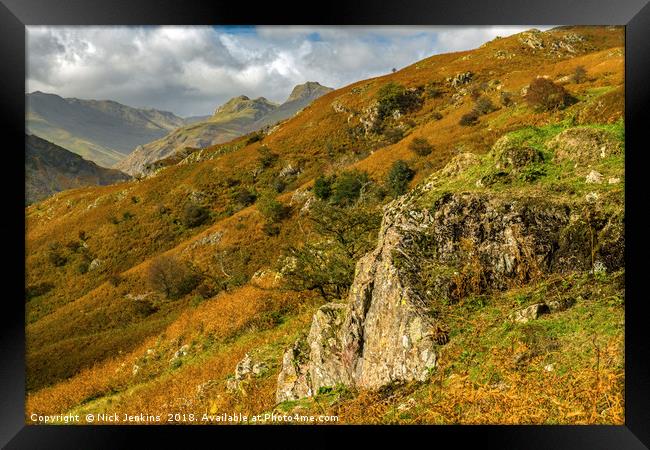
[276,178,624,402]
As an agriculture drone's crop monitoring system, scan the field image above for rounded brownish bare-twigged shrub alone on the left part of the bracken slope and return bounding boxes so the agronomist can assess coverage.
[147,255,201,299]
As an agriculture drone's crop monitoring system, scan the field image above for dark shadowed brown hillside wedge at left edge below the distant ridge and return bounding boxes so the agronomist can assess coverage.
[25,135,131,204]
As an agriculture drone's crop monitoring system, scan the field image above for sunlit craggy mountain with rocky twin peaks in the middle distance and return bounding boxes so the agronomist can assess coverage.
[115,82,332,175]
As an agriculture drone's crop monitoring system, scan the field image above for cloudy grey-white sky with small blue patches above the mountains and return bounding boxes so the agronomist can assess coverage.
[26,25,549,117]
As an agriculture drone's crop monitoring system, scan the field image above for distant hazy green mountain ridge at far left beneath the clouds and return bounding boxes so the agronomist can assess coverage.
[25,91,186,167]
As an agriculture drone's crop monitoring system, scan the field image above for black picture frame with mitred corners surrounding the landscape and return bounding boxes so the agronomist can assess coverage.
[0,0,650,449]
